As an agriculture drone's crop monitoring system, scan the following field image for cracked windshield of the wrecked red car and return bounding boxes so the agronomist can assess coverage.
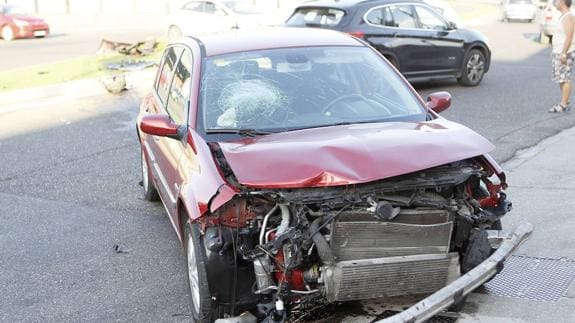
[199,47,425,132]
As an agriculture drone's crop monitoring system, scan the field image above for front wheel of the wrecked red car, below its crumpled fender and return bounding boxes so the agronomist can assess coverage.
[184,221,218,323]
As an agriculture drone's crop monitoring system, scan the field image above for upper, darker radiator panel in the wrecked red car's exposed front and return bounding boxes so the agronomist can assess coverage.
[330,209,453,261]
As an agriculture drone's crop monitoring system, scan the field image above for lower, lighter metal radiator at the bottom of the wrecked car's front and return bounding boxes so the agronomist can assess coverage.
[324,253,459,302]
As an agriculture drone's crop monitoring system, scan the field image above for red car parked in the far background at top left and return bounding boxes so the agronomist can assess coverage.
[0,5,50,41]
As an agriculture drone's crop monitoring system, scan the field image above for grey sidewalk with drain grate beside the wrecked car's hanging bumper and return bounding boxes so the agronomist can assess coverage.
[458,128,575,323]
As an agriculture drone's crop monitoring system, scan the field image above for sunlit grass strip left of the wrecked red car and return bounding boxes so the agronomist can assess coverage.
[0,43,165,92]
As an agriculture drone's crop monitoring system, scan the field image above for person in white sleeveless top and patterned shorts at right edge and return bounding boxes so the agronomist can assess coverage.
[549,0,575,112]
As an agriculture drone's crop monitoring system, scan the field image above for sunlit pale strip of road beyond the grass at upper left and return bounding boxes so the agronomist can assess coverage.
[0,28,162,71]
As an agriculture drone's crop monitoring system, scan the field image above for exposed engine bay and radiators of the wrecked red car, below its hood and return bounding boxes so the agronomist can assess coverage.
[199,154,528,322]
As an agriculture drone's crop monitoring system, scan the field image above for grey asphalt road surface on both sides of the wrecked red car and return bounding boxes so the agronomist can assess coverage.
[0,13,575,322]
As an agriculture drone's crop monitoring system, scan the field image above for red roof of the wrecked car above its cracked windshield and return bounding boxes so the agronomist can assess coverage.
[196,27,365,56]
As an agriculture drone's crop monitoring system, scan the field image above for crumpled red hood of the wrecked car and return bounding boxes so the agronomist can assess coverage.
[219,119,494,188]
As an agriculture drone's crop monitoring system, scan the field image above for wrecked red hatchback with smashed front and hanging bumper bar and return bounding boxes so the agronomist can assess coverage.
[137,29,532,322]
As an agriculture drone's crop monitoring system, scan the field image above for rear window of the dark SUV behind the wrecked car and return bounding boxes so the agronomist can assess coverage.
[286,8,345,27]
